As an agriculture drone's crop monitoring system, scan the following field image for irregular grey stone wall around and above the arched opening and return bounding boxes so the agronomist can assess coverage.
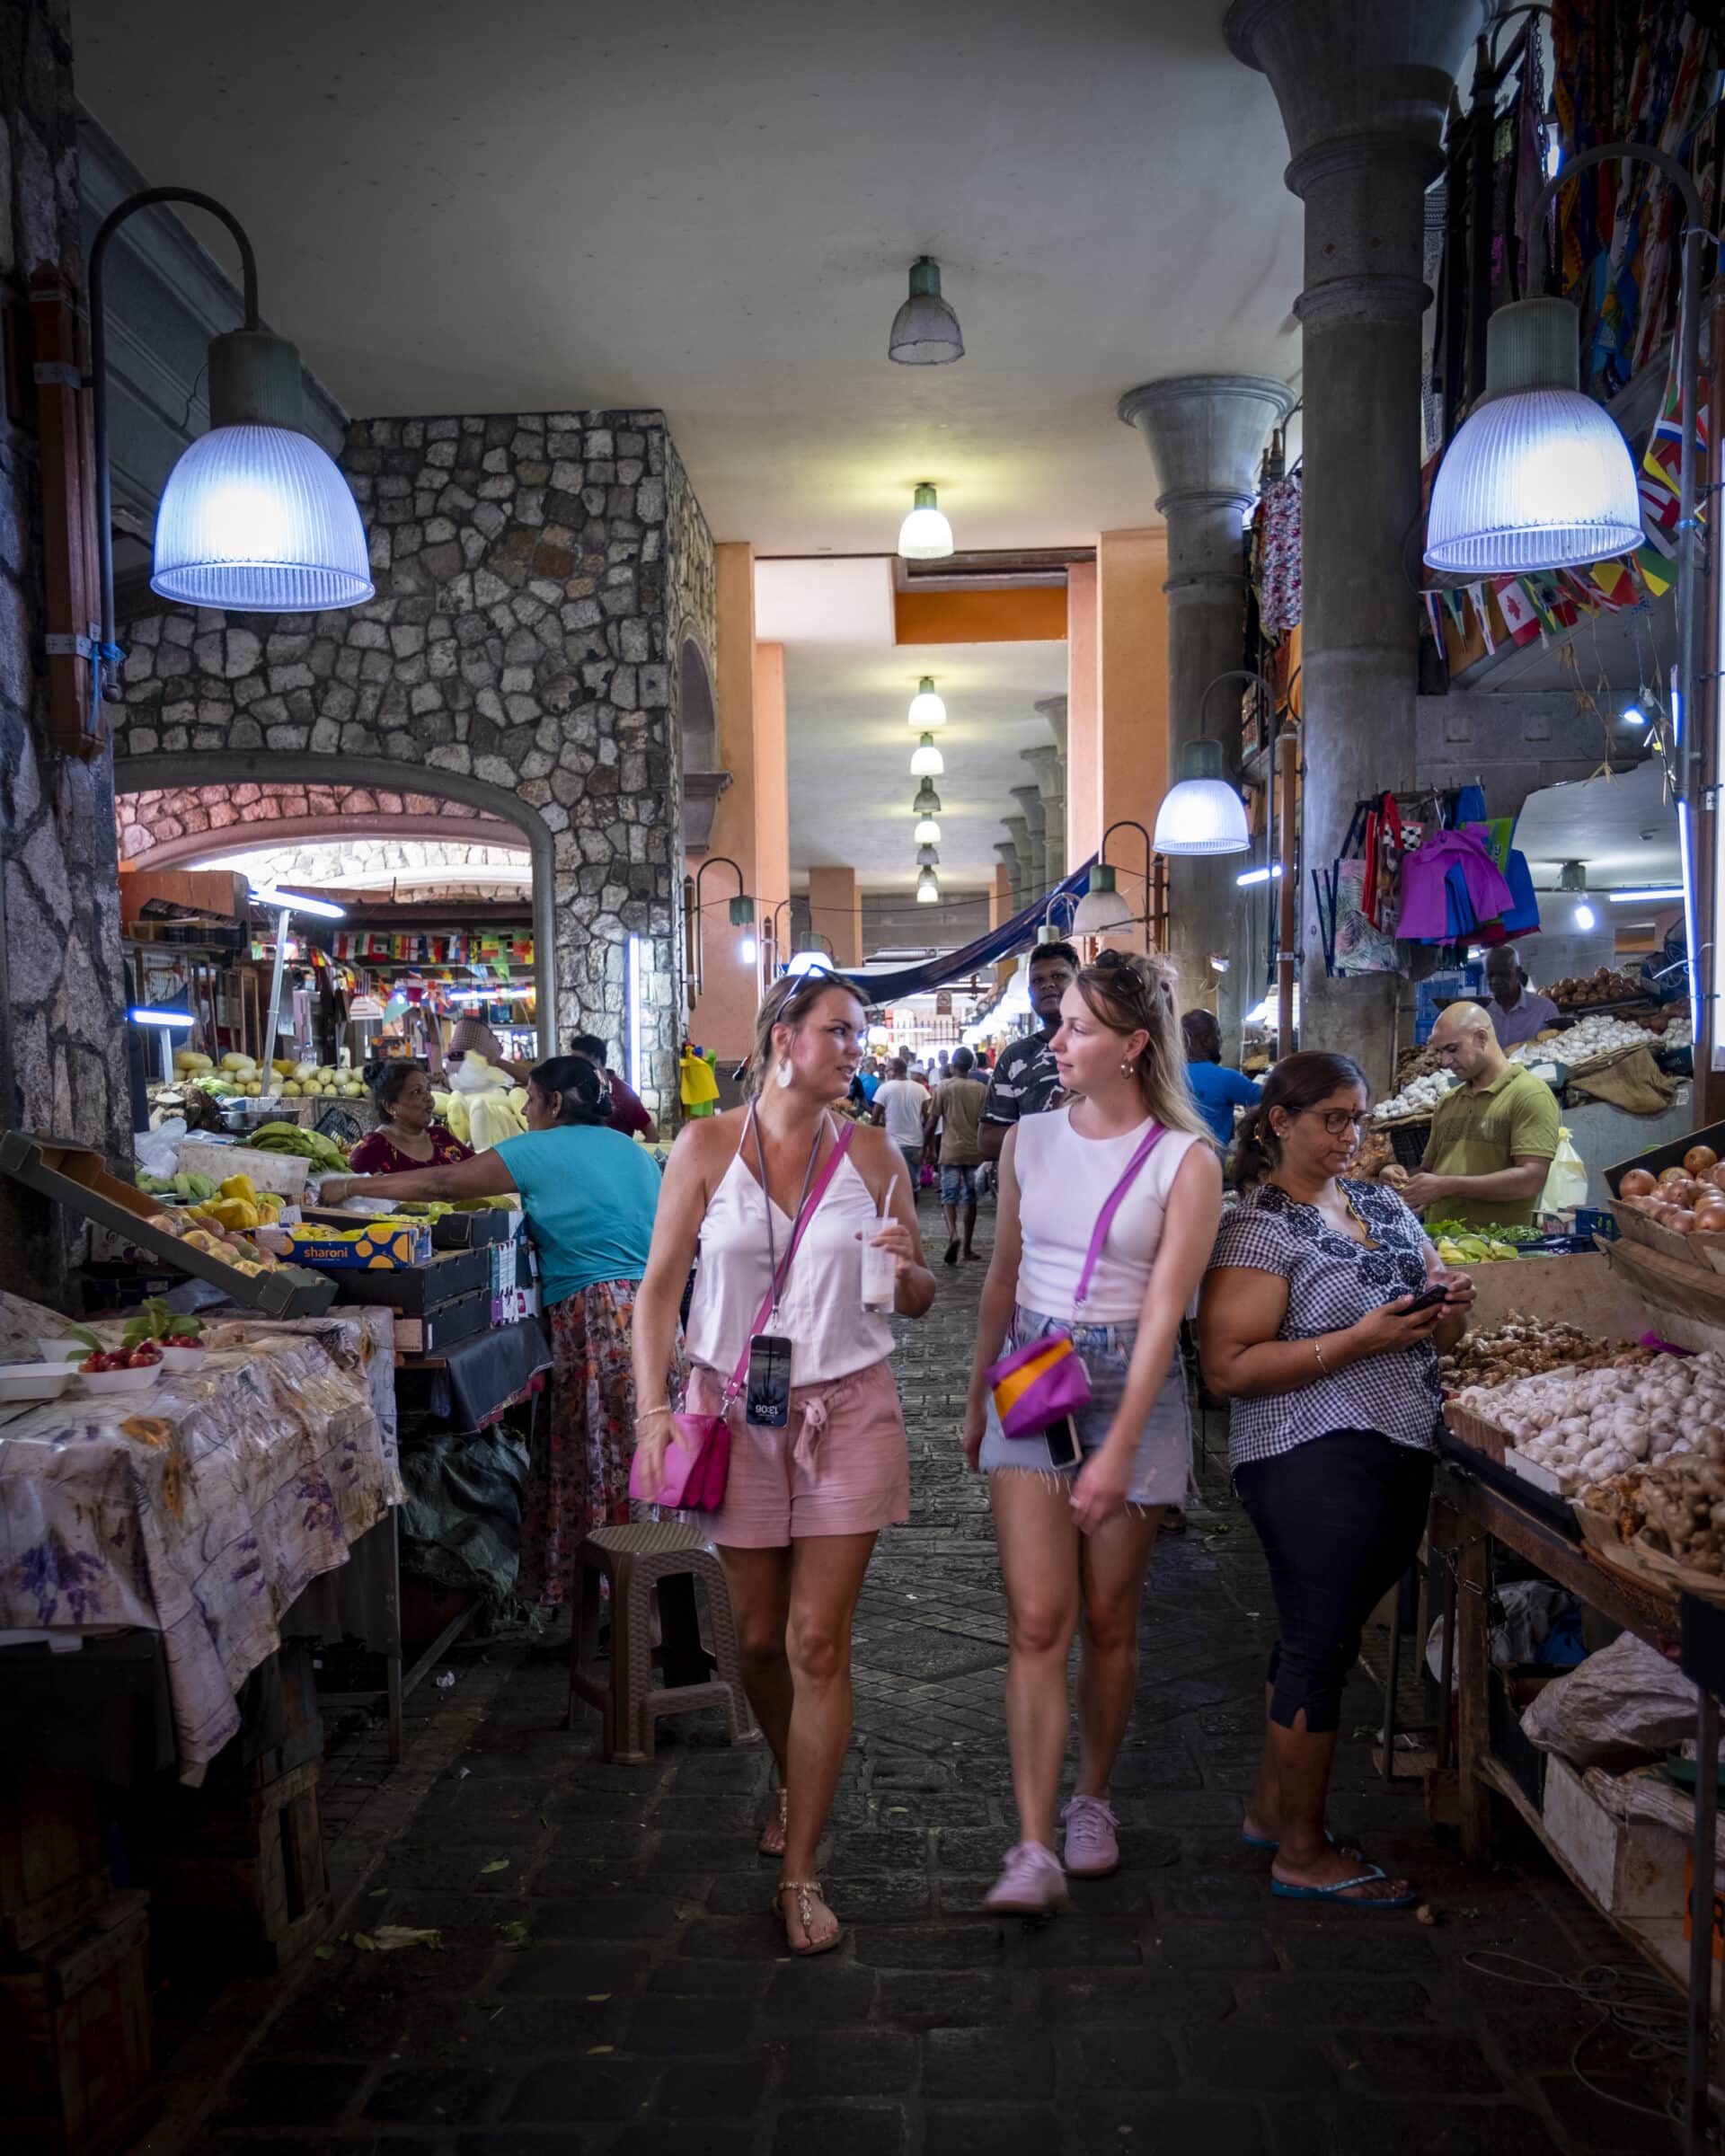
[117,411,712,1106]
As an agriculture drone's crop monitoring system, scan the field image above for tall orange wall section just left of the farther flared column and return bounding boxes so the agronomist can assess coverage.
[1100,530,1169,910]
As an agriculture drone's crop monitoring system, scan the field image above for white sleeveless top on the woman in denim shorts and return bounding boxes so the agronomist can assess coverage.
[1013,1106,1199,1326]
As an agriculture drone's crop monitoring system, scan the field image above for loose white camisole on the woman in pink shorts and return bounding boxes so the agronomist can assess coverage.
[686,1141,893,1384]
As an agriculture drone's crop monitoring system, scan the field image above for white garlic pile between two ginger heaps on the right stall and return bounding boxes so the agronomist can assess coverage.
[1462,1354,1725,1497]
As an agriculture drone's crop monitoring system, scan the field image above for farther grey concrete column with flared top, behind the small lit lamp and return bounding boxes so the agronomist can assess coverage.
[1119,376,1294,1063]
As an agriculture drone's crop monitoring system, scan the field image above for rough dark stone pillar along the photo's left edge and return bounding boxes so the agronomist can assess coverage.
[0,0,129,1304]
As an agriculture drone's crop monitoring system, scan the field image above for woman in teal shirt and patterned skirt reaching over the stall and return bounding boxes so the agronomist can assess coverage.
[322,1056,659,1604]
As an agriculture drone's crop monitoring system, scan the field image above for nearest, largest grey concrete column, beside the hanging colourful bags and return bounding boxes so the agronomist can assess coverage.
[1225,0,1482,1089]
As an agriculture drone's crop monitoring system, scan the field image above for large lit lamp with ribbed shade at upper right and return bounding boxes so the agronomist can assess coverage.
[1425,300,1641,576]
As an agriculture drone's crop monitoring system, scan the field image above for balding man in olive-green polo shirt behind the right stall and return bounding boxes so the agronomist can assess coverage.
[1402,1003,1557,1227]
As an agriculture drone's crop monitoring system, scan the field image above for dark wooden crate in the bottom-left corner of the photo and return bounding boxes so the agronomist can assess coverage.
[0,1891,151,2156]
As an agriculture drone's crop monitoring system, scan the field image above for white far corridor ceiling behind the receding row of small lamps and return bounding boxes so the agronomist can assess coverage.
[785,642,1066,890]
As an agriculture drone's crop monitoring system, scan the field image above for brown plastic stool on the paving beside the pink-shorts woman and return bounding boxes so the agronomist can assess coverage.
[570,1522,756,1763]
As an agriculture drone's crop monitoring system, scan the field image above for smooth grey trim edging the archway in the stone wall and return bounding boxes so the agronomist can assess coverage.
[114,748,562,1055]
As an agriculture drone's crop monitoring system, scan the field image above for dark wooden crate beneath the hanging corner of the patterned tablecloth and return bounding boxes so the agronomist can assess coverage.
[151,1759,330,1968]
